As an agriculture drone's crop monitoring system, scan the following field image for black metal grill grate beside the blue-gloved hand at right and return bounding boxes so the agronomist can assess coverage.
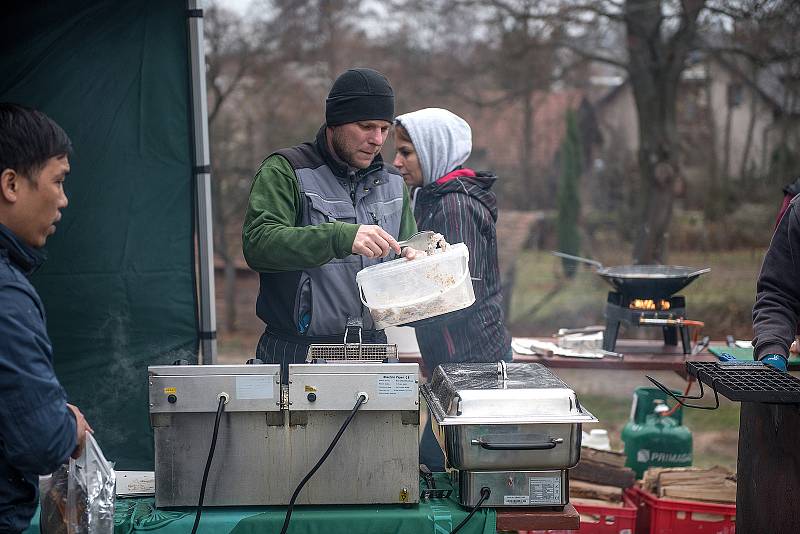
[686,362,800,404]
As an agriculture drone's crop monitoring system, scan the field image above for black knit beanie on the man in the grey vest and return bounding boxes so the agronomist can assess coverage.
[325,68,394,126]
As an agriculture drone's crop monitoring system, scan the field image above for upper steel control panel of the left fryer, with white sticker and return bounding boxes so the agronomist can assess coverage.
[147,365,280,414]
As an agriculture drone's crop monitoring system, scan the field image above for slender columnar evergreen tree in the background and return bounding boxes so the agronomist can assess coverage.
[557,110,581,277]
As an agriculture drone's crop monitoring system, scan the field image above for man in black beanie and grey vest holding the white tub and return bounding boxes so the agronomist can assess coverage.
[242,68,416,383]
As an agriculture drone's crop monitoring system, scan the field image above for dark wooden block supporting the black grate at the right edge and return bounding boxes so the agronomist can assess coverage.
[736,402,800,534]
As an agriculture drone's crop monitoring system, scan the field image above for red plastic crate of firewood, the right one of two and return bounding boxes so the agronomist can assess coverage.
[625,488,736,534]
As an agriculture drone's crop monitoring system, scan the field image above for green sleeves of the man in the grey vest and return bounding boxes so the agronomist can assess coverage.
[242,155,417,272]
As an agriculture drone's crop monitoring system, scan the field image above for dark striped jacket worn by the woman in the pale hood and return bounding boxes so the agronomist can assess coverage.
[412,169,511,372]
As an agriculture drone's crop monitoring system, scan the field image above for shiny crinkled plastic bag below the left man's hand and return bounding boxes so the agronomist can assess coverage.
[67,432,116,534]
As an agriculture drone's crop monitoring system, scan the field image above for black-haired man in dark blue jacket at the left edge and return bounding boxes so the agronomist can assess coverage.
[0,104,91,533]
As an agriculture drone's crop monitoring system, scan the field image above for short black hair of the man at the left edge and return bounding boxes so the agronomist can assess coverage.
[0,102,72,180]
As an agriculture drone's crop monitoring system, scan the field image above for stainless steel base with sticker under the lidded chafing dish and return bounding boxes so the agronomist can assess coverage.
[457,470,569,508]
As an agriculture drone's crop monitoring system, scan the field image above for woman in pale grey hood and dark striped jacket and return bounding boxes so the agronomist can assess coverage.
[394,108,512,469]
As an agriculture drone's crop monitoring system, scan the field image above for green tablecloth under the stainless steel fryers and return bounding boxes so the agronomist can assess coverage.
[25,474,497,534]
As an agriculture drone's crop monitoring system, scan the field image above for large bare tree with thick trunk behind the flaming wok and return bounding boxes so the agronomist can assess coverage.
[428,0,706,263]
